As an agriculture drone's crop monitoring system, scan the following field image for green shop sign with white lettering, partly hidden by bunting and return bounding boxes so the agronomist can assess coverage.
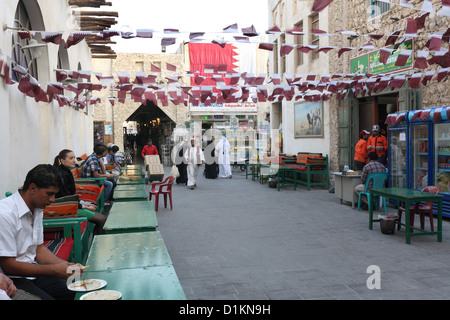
[350,40,413,74]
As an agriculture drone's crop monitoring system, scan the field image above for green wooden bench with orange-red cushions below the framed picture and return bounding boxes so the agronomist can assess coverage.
[282,153,329,190]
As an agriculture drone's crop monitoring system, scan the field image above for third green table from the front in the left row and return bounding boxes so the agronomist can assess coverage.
[103,201,158,234]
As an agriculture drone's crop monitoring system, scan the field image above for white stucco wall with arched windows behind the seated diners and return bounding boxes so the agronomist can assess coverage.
[0,0,94,198]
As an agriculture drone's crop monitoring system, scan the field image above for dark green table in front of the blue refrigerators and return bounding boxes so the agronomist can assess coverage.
[369,188,443,244]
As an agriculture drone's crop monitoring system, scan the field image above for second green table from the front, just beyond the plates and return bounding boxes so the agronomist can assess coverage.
[86,231,172,272]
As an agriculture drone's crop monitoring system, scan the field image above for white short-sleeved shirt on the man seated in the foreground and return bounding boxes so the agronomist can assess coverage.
[0,191,44,272]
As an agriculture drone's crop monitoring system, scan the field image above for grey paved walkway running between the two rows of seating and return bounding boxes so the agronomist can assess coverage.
[142,162,450,300]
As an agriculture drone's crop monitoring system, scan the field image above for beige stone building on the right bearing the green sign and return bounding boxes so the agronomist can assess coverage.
[269,0,450,171]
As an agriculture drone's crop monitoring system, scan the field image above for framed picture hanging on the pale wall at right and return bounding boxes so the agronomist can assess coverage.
[294,101,323,138]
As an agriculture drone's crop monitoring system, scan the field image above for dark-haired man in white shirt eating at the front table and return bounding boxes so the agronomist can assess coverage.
[0,165,79,300]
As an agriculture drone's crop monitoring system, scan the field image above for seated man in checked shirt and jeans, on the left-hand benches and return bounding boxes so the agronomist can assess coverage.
[81,144,116,201]
